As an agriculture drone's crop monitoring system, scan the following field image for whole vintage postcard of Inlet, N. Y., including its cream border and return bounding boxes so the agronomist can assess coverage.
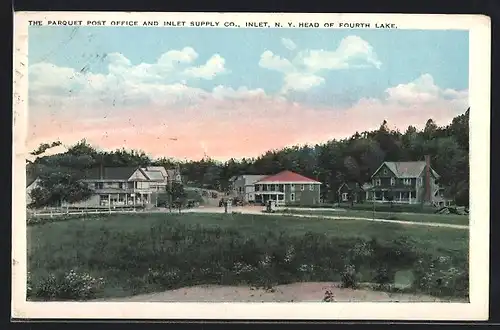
[12,12,490,321]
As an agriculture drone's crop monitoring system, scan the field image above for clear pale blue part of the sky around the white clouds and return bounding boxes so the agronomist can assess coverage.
[29,27,469,103]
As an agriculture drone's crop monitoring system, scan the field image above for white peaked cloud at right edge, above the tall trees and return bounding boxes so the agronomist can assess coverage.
[385,73,468,105]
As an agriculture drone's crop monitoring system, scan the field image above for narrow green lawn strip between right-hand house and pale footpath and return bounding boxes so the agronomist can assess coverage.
[284,209,469,225]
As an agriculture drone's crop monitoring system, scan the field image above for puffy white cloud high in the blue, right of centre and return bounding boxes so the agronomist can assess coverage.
[259,36,382,93]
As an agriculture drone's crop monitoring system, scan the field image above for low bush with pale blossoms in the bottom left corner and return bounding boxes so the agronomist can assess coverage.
[28,270,104,300]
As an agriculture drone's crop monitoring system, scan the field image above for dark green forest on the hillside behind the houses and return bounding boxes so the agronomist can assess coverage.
[27,109,470,206]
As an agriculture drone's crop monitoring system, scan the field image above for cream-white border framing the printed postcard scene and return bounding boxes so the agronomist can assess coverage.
[12,12,491,320]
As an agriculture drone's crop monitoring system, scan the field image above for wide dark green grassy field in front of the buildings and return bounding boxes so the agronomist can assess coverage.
[28,214,468,299]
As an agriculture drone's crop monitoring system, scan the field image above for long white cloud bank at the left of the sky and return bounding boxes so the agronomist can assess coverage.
[29,47,265,107]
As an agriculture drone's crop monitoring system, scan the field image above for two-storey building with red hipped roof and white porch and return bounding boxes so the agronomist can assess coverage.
[253,171,321,205]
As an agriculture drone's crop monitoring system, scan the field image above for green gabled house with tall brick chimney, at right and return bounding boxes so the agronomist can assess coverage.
[366,156,448,206]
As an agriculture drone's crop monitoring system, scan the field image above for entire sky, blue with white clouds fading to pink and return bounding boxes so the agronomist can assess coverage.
[27,26,469,160]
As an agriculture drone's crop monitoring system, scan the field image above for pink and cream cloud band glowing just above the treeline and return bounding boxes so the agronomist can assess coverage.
[27,98,465,159]
